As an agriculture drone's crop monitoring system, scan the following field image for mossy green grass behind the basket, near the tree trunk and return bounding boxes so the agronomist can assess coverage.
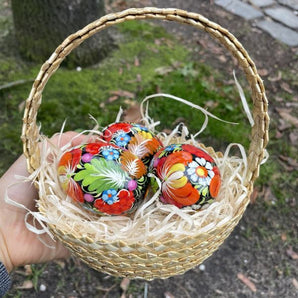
[0,21,249,173]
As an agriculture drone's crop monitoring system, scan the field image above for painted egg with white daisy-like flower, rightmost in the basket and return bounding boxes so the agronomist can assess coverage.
[150,144,221,210]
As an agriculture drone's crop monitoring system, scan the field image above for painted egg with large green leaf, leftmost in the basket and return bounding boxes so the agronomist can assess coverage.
[58,141,149,215]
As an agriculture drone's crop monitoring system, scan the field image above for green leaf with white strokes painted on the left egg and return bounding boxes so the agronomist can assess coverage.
[74,158,129,194]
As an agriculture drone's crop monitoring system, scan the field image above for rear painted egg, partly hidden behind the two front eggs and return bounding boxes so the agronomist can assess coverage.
[103,122,163,166]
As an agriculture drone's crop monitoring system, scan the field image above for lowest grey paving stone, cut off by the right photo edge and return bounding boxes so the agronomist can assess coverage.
[257,20,298,46]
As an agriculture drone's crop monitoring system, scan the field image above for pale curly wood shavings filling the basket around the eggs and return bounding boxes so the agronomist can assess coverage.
[28,128,248,243]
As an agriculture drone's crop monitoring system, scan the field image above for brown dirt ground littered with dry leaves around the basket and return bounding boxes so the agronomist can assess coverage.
[4,0,298,298]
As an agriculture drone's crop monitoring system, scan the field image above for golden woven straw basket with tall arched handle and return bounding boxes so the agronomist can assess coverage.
[22,8,269,280]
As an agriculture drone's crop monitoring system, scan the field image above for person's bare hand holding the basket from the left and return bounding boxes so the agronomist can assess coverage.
[0,132,84,272]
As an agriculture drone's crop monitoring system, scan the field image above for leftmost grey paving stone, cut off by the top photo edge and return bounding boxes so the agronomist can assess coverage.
[215,0,263,20]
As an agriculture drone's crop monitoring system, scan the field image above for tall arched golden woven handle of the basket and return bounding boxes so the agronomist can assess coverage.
[22,7,269,188]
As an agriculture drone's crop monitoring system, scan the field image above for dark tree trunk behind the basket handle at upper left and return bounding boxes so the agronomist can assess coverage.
[11,0,113,67]
